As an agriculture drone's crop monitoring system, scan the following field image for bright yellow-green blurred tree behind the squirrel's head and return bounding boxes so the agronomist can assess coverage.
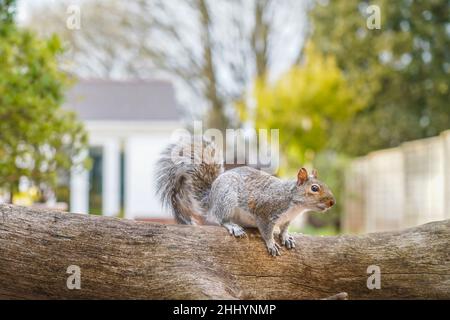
[238,45,365,174]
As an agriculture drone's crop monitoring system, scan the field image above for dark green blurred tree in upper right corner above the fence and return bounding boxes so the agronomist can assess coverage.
[311,0,450,155]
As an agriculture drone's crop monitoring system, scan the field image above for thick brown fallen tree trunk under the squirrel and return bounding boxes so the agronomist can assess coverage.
[0,205,450,299]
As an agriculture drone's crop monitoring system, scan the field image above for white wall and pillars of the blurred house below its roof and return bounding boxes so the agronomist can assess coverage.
[70,121,180,219]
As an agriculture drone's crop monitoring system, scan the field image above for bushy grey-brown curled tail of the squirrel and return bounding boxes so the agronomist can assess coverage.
[156,137,223,224]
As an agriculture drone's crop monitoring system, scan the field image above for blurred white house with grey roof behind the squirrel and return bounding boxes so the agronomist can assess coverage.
[64,80,181,220]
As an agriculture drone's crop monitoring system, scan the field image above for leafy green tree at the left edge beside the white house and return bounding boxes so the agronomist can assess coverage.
[0,1,87,202]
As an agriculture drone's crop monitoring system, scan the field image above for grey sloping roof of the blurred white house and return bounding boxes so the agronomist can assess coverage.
[64,80,180,121]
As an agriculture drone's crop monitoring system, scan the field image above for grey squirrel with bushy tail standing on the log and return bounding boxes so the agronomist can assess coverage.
[156,137,336,256]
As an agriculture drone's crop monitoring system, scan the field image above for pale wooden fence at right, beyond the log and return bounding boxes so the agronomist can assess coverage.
[342,130,450,233]
